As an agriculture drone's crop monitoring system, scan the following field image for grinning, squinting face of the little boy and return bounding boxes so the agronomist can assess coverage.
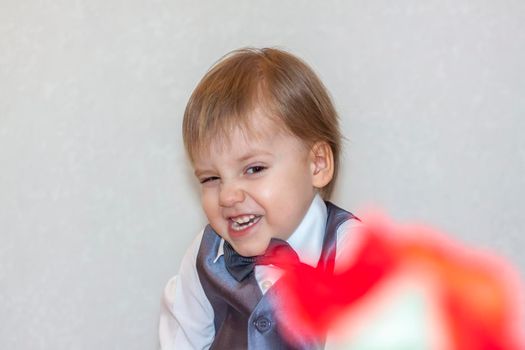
[194,112,315,256]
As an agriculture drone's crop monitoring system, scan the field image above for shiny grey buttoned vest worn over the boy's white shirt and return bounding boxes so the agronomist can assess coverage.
[197,202,354,350]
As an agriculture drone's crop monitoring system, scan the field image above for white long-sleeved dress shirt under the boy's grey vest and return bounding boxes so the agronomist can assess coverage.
[159,195,358,350]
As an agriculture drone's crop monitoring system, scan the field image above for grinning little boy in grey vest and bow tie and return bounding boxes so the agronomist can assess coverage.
[159,49,355,349]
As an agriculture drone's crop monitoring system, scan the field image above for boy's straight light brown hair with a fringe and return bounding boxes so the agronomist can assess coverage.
[182,48,341,199]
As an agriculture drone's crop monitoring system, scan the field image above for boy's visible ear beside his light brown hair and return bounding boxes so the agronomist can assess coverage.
[310,141,334,188]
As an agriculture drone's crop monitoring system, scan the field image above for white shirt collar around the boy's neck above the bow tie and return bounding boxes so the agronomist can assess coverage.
[213,194,328,267]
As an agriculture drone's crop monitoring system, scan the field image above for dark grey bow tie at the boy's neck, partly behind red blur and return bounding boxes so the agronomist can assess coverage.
[224,238,300,282]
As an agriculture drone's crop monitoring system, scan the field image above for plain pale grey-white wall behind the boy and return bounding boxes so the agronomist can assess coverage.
[0,0,525,350]
